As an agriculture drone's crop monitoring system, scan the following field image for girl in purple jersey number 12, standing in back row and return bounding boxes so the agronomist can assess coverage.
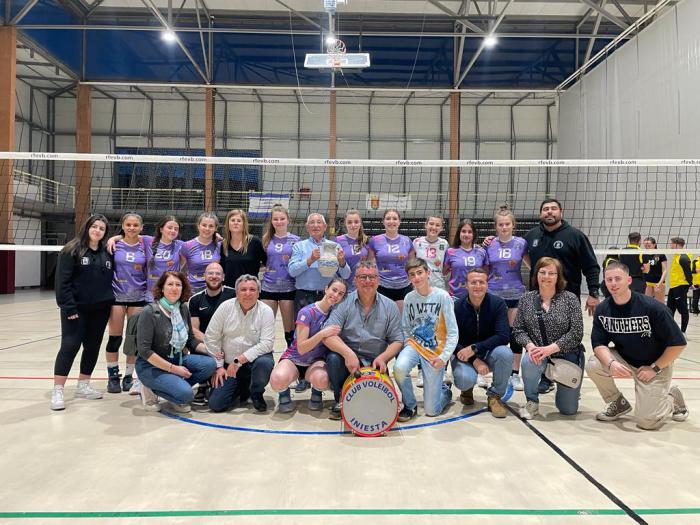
[368,208,416,312]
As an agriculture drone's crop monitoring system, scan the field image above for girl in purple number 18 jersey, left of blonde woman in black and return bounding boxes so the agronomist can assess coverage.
[180,211,221,294]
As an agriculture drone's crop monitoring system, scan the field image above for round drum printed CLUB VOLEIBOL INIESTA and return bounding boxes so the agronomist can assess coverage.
[340,367,399,437]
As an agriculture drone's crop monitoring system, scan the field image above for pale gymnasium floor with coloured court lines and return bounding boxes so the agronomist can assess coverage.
[0,291,700,525]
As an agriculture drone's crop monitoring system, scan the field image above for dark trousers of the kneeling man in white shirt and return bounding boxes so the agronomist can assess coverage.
[209,353,275,412]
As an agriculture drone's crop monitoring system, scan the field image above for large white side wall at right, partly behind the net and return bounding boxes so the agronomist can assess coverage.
[556,0,700,248]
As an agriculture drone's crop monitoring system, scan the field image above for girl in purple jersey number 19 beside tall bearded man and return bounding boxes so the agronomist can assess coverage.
[486,206,530,390]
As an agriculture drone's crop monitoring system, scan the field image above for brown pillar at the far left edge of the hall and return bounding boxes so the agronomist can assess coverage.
[0,26,17,294]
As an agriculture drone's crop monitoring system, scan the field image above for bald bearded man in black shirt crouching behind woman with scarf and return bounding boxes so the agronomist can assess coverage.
[188,263,236,406]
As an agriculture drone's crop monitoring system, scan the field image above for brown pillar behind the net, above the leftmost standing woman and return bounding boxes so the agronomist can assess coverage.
[75,84,92,235]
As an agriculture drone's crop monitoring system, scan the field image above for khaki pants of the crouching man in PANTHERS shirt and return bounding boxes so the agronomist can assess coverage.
[586,348,673,430]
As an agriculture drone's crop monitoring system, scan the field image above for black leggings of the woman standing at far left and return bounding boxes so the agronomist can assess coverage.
[53,306,111,376]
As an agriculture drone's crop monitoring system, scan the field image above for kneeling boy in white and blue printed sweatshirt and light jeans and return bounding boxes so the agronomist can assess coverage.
[394,259,459,422]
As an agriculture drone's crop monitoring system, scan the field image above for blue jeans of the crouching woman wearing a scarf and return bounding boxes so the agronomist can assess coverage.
[136,354,216,405]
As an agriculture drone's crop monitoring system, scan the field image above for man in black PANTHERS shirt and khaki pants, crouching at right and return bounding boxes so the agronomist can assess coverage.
[586,262,688,430]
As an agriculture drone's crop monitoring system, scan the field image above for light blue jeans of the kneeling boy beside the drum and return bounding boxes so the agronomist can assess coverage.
[394,346,452,416]
